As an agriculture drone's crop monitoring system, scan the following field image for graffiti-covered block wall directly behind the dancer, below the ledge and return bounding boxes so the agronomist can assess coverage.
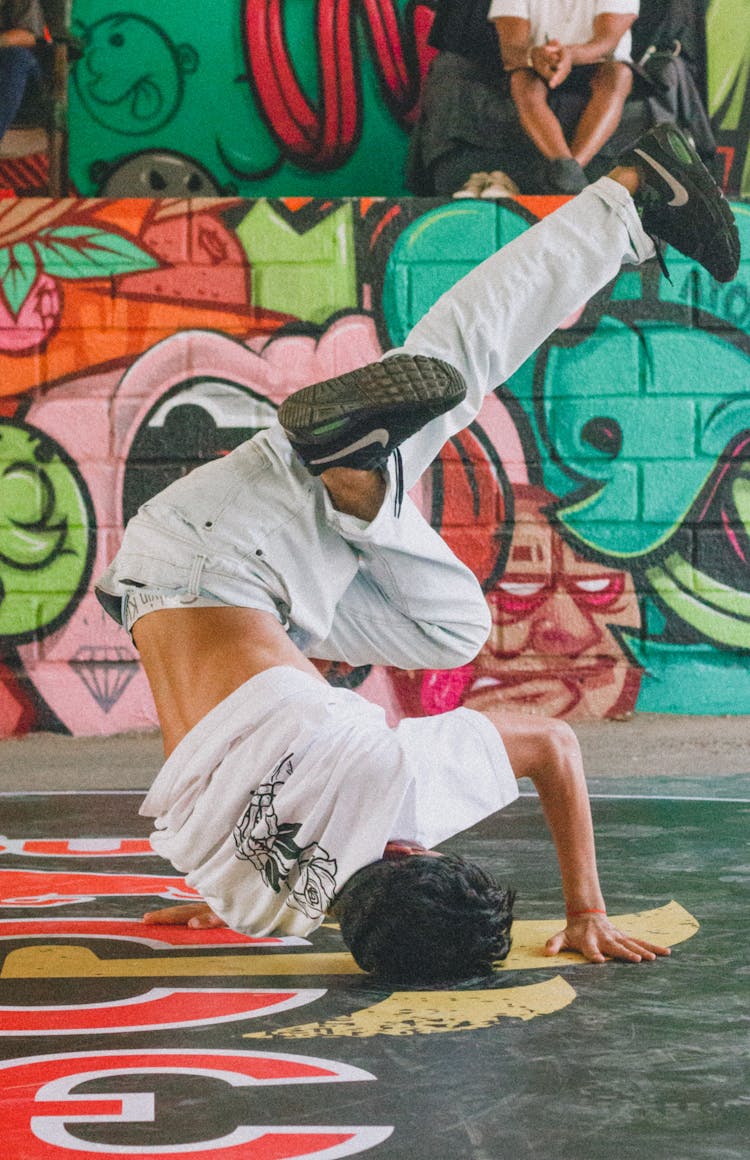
[0,190,750,735]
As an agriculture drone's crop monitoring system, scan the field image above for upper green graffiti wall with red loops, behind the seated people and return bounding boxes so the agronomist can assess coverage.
[51,0,750,197]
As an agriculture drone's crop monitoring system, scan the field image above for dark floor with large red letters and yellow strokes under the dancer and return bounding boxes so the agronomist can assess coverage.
[0,793,750,1160]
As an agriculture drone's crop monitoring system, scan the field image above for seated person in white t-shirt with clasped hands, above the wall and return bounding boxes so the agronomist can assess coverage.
[489,0,639,194]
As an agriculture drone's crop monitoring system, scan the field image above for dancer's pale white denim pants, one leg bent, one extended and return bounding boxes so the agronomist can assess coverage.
[96,177,654,668]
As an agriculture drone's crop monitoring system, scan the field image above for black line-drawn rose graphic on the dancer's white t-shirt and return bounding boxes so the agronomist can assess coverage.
[233,753,337,919]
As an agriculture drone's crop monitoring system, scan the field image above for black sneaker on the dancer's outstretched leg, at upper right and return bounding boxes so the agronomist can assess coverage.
[619,124,740,282]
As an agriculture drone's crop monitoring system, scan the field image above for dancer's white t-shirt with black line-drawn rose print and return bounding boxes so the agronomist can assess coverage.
[140,666,518,935]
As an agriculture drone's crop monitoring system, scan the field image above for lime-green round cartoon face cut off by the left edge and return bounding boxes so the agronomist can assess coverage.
[0,420,92,644]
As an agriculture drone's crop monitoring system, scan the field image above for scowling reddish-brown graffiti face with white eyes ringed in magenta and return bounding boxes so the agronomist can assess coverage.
[463,487,640,718]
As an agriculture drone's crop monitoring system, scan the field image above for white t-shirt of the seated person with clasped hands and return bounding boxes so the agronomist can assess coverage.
[488,0,640,60]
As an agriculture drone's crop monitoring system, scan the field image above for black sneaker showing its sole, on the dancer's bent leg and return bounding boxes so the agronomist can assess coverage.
[278,355,466,476]
